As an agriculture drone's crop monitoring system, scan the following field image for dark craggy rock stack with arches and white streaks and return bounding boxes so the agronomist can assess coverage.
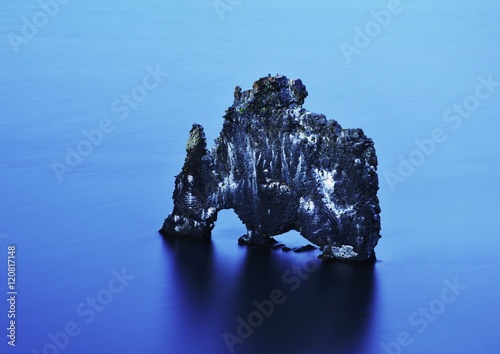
[160,75,380,262]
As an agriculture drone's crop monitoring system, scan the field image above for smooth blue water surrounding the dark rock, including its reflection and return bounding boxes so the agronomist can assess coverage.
[0,0,500,354]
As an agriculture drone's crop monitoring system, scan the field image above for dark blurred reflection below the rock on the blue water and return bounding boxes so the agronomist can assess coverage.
[165,238,376,354]
